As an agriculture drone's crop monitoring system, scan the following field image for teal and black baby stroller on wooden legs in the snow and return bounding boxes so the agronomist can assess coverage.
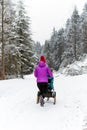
[36,77,56,106]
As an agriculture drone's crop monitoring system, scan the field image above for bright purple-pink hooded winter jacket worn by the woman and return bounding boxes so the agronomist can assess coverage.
[34,61,53,83]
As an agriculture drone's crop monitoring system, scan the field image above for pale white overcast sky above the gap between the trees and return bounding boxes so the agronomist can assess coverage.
[24,0,87,44]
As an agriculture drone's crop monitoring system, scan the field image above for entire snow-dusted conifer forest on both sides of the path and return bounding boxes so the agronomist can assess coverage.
[0,0,87,79]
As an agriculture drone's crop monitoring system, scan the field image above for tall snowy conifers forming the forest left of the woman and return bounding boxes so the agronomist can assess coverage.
[0,0,35,79]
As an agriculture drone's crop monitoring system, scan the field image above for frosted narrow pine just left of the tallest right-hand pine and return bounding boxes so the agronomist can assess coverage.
[61,19,73,67]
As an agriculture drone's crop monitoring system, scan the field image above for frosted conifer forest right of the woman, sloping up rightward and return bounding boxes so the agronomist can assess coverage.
[35,3,87,70]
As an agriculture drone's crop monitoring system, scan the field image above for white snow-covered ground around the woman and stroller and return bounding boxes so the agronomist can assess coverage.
[0,73,87,130]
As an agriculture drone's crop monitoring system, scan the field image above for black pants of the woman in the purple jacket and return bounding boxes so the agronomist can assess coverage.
[37,82,48,98]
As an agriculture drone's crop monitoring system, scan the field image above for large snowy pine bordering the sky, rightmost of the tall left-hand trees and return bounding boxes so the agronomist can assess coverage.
[16,1,34,78]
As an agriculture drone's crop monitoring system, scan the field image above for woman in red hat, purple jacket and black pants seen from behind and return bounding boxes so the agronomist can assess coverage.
[34,55,53,105]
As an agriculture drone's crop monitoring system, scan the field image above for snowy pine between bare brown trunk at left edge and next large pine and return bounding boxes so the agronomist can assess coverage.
[4,0,17,76]
